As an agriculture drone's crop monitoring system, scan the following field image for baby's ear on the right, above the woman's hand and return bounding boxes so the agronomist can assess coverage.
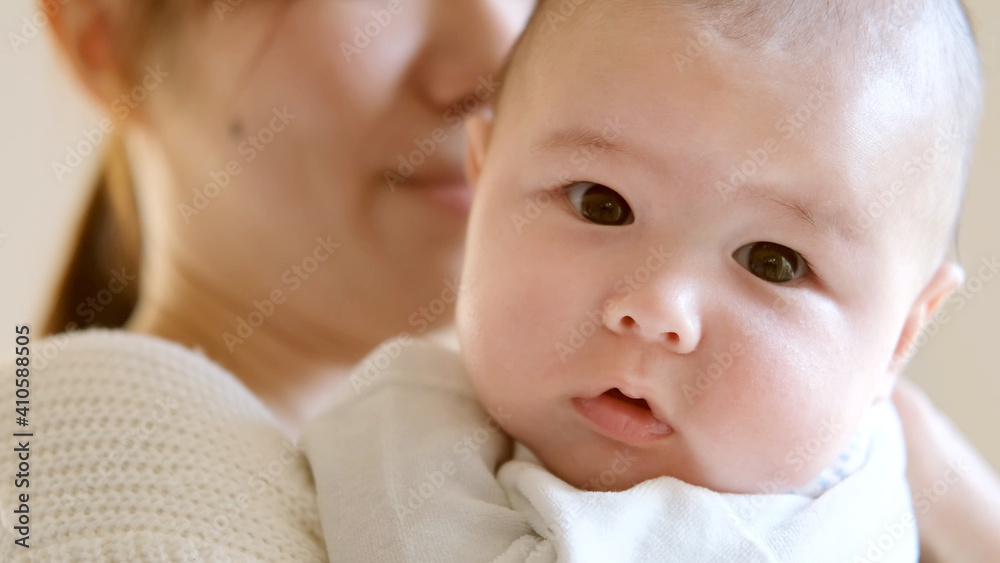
[877,260,965,399]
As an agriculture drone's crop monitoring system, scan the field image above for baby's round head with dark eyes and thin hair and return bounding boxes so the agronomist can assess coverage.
[458,0,981,493]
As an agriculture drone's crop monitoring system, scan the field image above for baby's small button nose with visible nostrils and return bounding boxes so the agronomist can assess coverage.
[604,271,702,354]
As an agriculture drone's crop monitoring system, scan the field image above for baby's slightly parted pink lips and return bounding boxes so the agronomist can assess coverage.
[573,388,673,446]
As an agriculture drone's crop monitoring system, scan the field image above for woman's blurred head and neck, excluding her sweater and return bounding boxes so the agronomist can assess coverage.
[41,0,531,434]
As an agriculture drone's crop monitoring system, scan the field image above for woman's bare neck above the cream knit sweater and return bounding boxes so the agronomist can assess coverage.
[126,127,364,438]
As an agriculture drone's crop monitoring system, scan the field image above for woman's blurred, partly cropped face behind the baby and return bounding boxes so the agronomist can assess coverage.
[139,0,534,349]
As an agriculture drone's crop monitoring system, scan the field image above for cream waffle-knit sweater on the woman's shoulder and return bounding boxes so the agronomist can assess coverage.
[0,330,327,563]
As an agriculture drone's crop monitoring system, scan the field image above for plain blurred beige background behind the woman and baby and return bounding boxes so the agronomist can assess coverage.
[0,0,1000,468]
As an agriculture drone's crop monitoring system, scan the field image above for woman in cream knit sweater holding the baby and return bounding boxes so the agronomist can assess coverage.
[0,0,1000,560]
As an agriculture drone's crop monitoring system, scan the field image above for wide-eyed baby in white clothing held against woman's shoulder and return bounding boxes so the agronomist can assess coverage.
[304,0,982,561]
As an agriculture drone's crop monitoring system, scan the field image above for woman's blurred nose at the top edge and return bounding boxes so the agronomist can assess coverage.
[413,0,534,108]
